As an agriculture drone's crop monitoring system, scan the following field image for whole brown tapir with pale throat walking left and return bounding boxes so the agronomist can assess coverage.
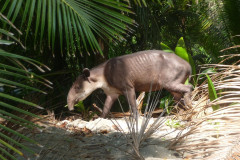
[67,50,192,118]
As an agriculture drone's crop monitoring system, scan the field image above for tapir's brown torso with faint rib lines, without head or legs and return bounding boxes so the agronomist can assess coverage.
[104,50,191,91]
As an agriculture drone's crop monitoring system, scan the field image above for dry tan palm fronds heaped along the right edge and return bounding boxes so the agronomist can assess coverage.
[170,55,240,160]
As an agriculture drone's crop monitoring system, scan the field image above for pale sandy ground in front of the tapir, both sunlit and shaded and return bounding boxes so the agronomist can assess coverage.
[19,118,186,160]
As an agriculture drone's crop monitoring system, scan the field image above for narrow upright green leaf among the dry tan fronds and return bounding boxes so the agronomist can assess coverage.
[206,74,220,111]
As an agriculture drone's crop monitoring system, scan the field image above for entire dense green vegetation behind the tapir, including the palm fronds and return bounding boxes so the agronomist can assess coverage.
[0,0,240,159]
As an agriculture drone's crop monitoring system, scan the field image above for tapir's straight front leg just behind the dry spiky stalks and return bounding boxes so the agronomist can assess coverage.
[123,88,138,117]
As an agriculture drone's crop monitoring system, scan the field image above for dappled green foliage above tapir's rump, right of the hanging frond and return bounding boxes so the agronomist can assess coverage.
[126,0,232,65]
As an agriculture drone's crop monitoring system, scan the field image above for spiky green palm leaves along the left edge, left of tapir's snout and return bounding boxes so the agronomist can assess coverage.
[0,13,51,160]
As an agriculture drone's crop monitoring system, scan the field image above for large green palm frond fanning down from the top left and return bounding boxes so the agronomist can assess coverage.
[0,0,133,53]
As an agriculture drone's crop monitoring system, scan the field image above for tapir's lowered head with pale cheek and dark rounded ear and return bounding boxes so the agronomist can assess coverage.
[67,68,97,110]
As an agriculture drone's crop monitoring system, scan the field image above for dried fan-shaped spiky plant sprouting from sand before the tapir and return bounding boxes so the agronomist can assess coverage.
[112,89,168,160]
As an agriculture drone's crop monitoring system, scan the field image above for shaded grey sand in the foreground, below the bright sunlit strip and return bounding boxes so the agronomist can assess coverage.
[18,118,182,160]
